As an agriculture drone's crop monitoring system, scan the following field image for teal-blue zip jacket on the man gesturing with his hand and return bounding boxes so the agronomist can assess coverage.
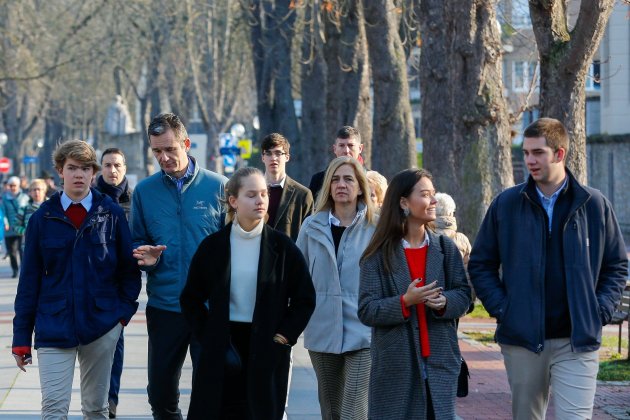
[131,159,227,312]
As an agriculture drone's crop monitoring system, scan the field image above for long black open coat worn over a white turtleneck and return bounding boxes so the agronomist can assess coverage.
[180,224,315,420]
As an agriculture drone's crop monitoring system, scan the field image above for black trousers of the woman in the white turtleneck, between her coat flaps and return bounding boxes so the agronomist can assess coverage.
[220,322,252,420]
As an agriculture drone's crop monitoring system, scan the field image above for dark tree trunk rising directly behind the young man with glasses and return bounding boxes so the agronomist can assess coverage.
[250,0,300,143]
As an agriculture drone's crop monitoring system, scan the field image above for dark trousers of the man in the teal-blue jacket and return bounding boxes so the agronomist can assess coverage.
[146,306,201,420]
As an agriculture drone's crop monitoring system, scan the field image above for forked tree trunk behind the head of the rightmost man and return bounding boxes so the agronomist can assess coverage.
[529,0,615,183]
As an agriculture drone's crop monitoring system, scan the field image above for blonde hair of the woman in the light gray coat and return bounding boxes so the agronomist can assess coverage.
[315,156,376,224]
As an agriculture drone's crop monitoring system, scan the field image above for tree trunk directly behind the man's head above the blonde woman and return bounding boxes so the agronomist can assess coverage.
[323,1,372,166]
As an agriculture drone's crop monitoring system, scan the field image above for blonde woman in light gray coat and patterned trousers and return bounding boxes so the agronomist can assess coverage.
[297,156,375,420]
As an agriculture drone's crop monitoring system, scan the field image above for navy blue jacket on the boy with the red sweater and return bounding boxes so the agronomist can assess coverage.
[13,189,142,348]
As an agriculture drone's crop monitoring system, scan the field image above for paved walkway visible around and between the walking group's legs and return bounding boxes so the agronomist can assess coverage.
[0,260,630,420]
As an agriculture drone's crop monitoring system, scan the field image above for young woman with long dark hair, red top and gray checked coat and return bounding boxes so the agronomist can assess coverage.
[358,169,471,419]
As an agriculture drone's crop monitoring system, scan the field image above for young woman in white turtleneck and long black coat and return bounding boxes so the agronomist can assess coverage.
[180,167,315,420]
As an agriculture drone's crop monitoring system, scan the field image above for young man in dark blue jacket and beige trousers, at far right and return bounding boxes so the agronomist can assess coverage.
[468,118,628,420]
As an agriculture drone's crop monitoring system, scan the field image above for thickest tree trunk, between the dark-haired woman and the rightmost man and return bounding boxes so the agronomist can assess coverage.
[420,0,514,240]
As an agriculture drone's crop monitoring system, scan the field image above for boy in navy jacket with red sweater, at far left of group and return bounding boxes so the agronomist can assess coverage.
[13,140,142,419]
